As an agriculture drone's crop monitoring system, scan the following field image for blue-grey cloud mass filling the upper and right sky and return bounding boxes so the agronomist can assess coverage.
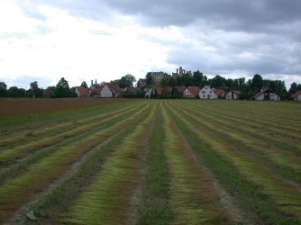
[29,0,301,78]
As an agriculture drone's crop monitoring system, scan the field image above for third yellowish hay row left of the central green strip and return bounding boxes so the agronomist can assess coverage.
[0,103,144,167]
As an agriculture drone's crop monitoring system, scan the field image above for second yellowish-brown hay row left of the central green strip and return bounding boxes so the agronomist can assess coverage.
[0,103,147,222]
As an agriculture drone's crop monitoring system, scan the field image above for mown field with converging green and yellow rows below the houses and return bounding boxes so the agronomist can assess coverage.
[0,100,301,225]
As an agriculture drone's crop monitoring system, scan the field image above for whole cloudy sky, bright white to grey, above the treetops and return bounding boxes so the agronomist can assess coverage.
[0,0,301,88]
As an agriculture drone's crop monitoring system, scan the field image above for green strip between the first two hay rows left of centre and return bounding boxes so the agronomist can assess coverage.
[16,106,149,225]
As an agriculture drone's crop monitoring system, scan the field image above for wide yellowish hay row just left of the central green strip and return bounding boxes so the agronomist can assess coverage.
[64,103,154,225]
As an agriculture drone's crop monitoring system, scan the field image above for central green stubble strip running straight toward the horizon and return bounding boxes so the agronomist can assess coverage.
[137,102,172,225]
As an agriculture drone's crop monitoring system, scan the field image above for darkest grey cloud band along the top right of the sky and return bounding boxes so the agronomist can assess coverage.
[107,0,301,30]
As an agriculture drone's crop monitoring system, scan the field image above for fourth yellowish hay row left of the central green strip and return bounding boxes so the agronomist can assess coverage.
[0,101,134,148]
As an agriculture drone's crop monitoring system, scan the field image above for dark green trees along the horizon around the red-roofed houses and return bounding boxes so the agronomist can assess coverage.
[0,71,301,100]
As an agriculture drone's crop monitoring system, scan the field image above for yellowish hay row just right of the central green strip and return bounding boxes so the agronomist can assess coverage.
[164,104,230,225]
